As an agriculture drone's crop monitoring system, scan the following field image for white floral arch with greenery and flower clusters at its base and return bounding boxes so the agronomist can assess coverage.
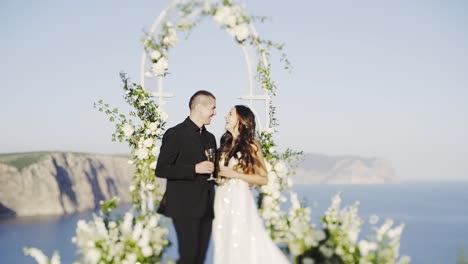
[25,0,409,264]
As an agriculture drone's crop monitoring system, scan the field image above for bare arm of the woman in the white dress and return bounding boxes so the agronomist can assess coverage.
[218,144,268,185]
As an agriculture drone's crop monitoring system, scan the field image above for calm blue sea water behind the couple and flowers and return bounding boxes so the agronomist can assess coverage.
[0,182,468,264]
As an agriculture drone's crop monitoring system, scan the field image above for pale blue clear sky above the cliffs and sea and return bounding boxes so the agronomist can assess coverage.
[0,0,468,181]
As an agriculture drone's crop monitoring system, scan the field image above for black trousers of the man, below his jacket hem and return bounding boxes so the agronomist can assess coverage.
[172,217,213,264]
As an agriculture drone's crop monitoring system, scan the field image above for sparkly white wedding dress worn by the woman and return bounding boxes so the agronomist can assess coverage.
[213,158,289,264]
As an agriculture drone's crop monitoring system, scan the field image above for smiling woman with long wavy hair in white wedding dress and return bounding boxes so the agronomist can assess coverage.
[213,105,289,264]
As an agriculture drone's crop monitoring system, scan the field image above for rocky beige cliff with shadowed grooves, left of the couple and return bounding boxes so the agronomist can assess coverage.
[0,152,133,216]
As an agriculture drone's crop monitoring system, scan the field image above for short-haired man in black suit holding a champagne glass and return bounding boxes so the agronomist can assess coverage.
[155,90,216,264]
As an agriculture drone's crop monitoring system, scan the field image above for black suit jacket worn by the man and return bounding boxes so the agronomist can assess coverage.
[155,117,216,218]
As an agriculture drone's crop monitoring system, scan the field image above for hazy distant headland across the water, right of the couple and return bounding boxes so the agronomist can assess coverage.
[293,153,398,184]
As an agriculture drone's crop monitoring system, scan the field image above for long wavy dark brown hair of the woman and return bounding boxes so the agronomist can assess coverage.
[217,105,267,174]
